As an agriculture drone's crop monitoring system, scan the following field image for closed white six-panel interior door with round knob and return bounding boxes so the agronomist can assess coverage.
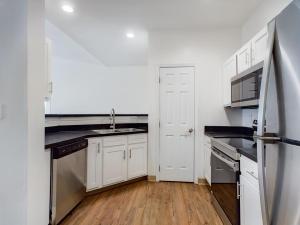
[160,67,195,182]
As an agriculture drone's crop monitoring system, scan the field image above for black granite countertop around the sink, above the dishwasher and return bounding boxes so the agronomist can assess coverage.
[45,129,148,149]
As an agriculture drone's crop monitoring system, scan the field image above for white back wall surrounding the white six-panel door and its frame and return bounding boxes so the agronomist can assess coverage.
[148,29,242,177]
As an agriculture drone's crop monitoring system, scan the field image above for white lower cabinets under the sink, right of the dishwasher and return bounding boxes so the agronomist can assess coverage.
[87,134,148,191]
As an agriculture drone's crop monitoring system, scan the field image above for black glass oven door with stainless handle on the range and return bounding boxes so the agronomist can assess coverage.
[211,148,240,225]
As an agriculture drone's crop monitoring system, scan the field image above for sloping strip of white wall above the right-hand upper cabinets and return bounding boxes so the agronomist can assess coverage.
[242,0,292,43]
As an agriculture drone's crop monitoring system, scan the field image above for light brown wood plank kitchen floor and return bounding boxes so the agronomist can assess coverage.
[62,181,223,225]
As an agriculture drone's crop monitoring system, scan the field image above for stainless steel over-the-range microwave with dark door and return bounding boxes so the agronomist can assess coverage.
[231,62,263,107]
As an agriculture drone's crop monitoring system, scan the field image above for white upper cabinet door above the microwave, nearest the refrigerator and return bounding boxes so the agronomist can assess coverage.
[251,27,268,65]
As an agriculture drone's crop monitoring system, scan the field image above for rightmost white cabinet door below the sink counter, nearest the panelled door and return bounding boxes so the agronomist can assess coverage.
[128,143,147,179]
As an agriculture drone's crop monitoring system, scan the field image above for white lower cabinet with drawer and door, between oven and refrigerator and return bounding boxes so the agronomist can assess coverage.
[240,157,263,225]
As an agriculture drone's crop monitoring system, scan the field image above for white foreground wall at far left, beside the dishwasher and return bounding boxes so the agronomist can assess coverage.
[0,0,50,225]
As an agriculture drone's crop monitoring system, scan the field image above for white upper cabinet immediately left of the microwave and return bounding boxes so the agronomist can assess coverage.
[223,54,237,106]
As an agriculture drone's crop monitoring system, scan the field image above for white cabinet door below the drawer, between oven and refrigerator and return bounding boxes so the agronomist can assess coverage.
[240,176,263,225]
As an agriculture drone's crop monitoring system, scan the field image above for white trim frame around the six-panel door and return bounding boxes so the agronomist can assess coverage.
[155,64,199,184]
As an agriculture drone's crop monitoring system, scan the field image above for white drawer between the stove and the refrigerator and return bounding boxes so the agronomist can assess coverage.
[240,156,258,186]
